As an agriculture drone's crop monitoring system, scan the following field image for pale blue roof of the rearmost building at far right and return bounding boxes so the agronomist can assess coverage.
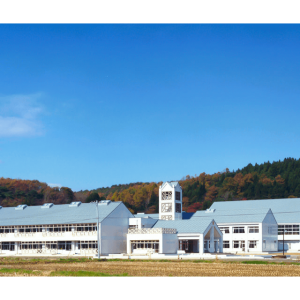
[211,198,300,223]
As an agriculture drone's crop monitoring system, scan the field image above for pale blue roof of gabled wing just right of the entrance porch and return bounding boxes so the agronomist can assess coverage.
[191,208,272,224]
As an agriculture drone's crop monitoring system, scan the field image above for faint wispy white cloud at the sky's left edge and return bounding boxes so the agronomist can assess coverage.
[0,94,43,137]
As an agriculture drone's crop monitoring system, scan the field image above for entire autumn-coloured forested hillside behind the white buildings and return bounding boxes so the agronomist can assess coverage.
[0,158,300,213]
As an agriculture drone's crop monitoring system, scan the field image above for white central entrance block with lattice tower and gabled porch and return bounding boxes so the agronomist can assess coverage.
[127,182,223,254]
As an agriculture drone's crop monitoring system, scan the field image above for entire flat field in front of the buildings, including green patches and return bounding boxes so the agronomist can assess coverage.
[0,258,300,277]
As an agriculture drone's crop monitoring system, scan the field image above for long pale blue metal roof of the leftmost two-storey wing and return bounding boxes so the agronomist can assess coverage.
[0,202,124,226]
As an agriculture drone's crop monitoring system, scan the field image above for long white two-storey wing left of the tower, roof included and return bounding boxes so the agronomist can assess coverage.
[0,200,133,256]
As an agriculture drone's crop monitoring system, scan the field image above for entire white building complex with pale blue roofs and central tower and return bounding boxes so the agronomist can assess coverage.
[0,182,286,256]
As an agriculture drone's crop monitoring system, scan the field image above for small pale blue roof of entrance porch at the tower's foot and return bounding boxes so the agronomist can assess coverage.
[153,218,213,234]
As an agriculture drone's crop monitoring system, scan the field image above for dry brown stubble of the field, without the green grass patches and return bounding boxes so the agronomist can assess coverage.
[0,261,300,277]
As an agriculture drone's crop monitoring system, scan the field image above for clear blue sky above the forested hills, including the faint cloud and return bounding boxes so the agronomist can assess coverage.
[0,24,300,191]
